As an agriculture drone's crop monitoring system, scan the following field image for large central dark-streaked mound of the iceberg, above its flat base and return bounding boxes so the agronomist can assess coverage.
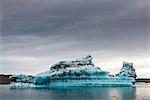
[34,55,109,84]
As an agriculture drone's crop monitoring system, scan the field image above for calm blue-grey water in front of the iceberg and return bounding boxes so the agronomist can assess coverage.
[0,85,150,100]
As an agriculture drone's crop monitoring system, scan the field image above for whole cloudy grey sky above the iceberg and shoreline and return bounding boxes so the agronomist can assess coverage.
[0,0,150,77]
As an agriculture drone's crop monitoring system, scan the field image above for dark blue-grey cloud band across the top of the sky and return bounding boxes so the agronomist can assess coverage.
[2,0,148,35]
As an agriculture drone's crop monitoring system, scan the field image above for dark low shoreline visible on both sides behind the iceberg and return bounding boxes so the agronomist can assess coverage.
[0,74,150,84]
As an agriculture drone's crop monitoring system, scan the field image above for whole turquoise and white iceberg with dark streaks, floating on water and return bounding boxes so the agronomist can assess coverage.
[10,55,136,88]
